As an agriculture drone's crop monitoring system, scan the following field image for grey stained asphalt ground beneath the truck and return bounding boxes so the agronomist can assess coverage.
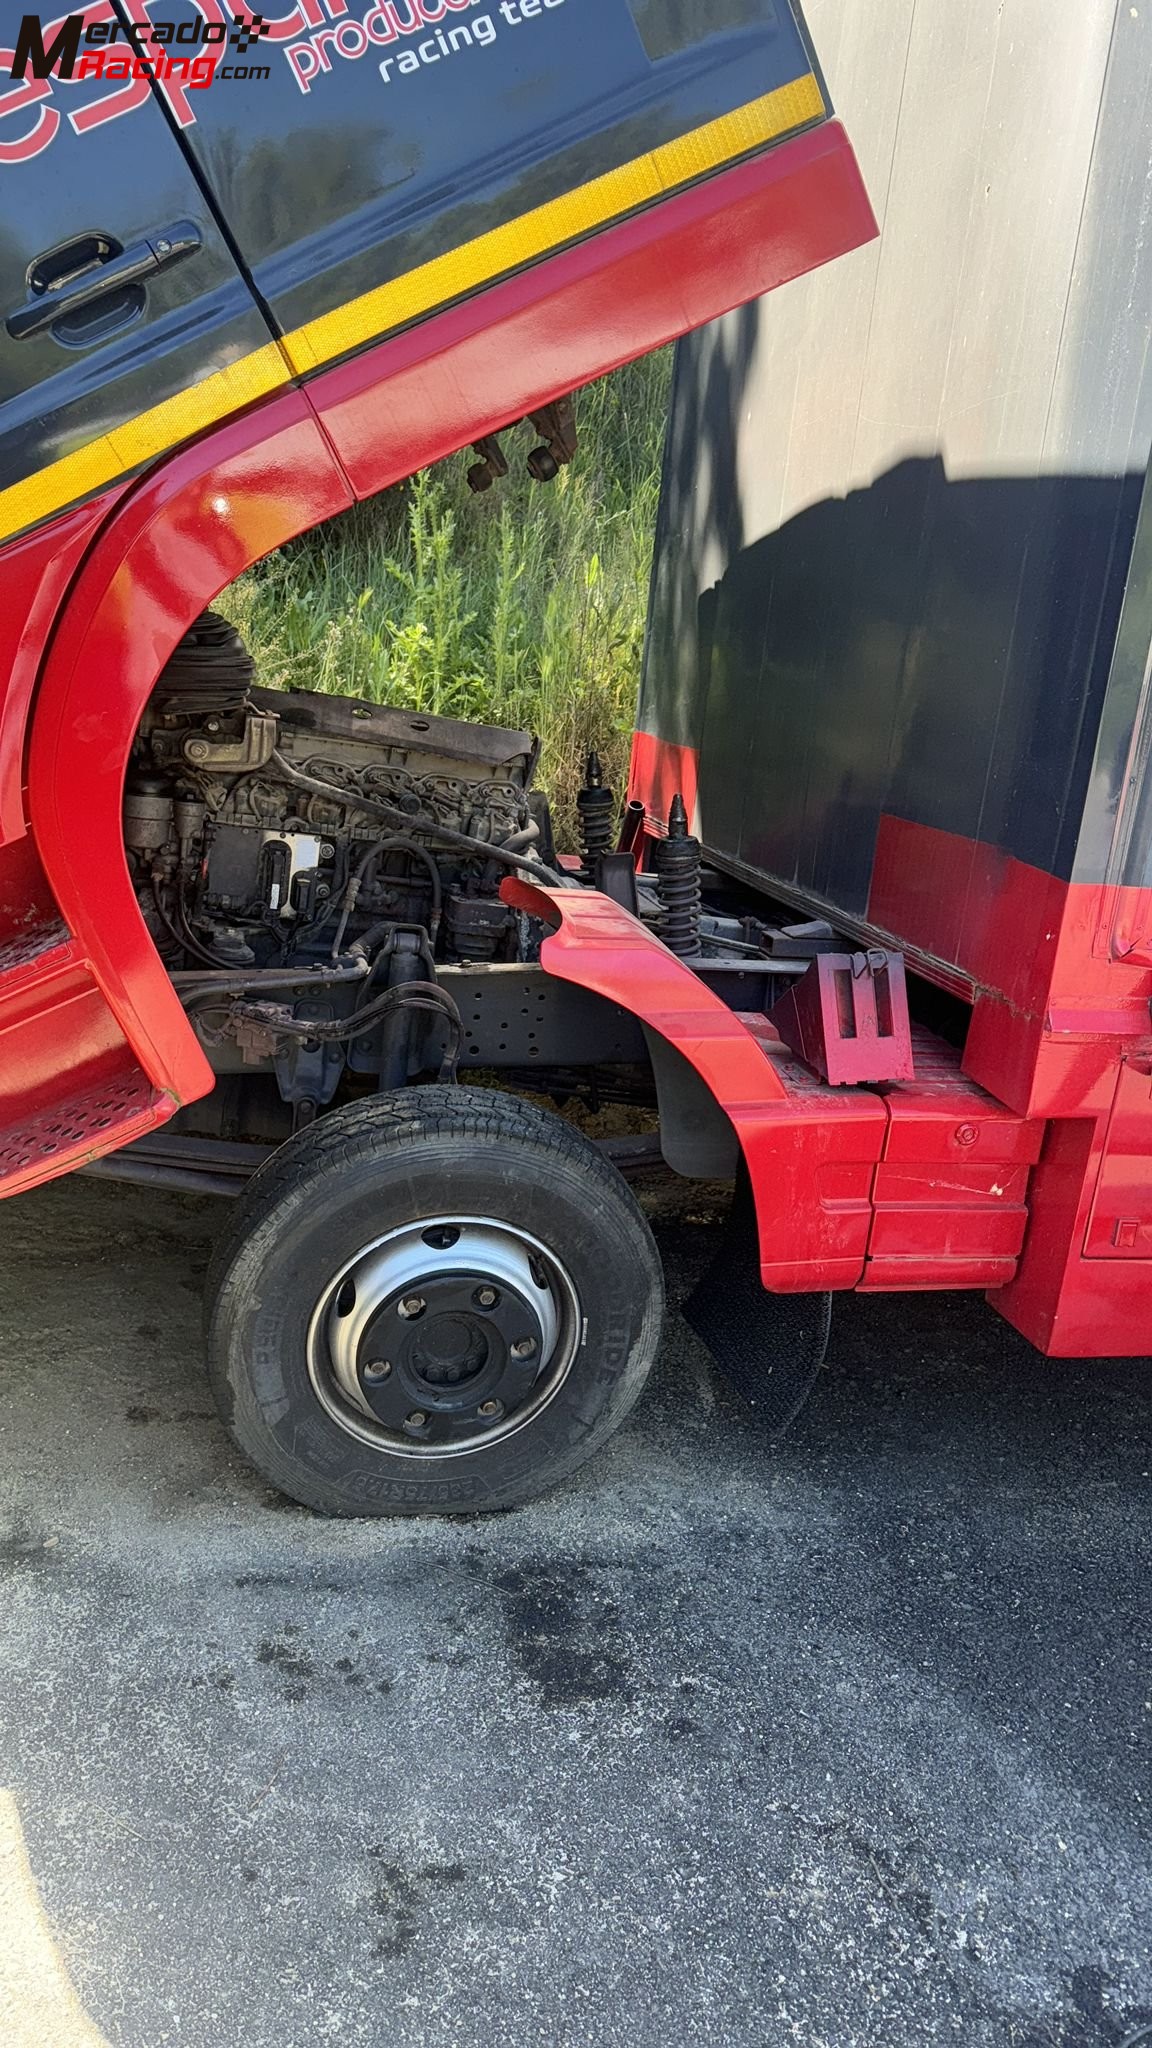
[0,1180,1152,2048]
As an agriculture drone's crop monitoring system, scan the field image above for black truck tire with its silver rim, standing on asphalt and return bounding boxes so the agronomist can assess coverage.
[207,1087,664,1516]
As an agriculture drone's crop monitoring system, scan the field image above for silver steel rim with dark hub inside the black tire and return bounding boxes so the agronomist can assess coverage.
[307,1214,582,1460]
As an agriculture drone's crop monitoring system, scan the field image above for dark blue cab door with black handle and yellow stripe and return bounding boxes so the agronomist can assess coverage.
[0,0,289,545]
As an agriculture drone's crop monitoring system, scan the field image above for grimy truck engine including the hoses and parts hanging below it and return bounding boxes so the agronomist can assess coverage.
[123,612,560,1106]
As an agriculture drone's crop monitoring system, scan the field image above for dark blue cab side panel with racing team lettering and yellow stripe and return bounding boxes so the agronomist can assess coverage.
[163,0,826,375]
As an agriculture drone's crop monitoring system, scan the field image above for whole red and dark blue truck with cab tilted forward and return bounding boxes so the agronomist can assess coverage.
[0,0,1152,1513]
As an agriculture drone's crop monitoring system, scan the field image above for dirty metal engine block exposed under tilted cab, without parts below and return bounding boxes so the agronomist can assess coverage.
[125,612,551,987]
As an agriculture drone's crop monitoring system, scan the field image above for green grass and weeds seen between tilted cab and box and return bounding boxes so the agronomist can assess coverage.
[219,350,670,844]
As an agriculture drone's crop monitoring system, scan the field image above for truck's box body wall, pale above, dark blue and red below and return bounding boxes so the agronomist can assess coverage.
[640,0,1152,1007]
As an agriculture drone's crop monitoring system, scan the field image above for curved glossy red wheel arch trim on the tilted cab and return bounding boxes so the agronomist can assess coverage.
[29,391,351,1130]
